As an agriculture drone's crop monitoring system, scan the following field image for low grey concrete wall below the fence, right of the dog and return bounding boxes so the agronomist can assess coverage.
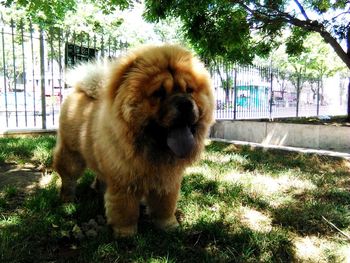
[211,121,350,153]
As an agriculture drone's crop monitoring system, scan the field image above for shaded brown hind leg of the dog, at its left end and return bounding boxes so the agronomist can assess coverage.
[54,145,86,202]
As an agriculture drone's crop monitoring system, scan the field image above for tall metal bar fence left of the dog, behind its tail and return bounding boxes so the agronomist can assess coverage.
[0,20,128,129]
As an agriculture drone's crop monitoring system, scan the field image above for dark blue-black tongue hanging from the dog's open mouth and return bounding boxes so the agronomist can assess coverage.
[167,126,195,158]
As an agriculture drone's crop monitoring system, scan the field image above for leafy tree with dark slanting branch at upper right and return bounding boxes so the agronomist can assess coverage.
[145,0,350,118]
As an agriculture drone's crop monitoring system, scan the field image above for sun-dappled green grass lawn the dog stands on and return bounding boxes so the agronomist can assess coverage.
[0,137,350,262]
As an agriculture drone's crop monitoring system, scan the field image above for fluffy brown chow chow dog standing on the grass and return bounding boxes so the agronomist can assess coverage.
[54,45,214,236]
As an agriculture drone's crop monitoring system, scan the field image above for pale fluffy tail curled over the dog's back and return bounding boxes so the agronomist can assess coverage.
[66,61,106,99]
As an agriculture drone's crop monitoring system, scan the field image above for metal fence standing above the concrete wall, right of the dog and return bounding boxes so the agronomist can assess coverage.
[208,61,348,120]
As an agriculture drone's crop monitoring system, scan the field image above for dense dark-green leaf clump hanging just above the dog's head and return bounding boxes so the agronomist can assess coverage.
[144,0,255,63]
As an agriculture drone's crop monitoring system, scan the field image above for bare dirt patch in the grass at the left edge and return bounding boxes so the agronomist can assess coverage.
[0,163,45,194]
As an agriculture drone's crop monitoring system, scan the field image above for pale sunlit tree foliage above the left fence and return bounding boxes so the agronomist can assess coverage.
[0,0,185,46]
